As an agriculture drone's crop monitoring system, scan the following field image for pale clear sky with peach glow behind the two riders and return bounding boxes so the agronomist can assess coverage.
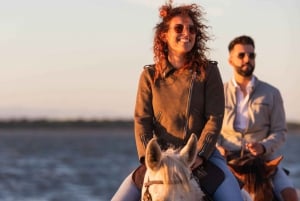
[0,0,300,122]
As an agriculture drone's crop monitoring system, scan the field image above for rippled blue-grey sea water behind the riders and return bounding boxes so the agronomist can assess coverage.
[0,127,300,201]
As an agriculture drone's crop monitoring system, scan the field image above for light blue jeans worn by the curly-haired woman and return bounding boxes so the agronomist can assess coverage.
[111,150,243,201]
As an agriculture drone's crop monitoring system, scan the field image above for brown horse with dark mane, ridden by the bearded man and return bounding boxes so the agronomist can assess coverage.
[227,153,283,201]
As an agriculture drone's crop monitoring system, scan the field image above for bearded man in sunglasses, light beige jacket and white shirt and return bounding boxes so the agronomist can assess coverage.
[217,35,298,201]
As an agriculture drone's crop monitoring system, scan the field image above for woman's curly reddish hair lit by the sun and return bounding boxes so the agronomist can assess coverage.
[153,0,210,80]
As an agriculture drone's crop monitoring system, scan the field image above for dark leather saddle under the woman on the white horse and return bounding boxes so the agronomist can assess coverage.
[132,161,225,195]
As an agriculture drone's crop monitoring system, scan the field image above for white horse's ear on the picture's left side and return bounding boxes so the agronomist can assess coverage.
[145,138,161,170]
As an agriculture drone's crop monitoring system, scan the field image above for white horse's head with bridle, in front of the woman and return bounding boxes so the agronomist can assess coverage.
[142,134,204,201]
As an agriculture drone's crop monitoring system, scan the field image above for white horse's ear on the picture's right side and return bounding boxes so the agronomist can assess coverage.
[179,133,197,166]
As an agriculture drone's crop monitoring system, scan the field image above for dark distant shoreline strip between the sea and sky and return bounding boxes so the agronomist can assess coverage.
[0,119,300,131]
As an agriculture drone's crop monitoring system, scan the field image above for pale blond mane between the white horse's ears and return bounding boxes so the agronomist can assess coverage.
[161,149,191,192]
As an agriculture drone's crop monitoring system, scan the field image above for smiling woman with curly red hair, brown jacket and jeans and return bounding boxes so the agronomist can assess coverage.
[112,2,242,201]
